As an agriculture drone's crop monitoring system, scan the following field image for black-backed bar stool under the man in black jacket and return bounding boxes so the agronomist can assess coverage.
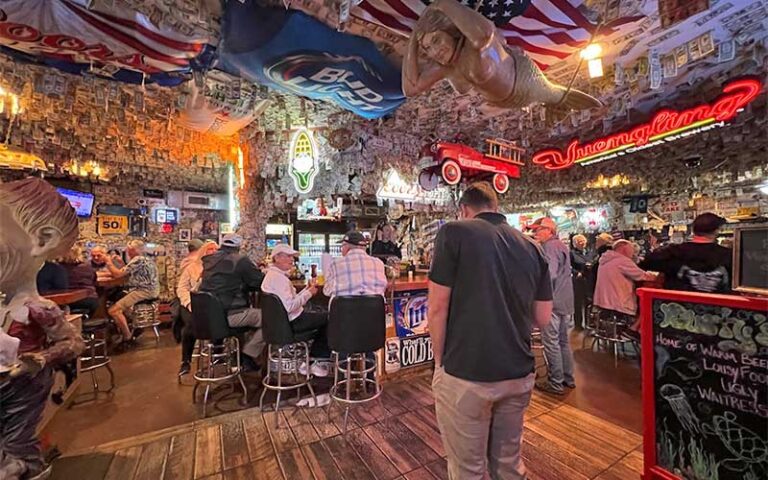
[191,292,248,417]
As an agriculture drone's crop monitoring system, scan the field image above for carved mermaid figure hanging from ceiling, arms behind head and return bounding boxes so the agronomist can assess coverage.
[403,0,601,110]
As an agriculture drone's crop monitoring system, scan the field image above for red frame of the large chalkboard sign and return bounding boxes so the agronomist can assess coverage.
[638,288,768,480]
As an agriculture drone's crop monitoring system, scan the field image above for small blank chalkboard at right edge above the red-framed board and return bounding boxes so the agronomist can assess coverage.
[733,224,768,294]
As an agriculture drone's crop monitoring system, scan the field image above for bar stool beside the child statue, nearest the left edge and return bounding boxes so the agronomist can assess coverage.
[69,311,115,408]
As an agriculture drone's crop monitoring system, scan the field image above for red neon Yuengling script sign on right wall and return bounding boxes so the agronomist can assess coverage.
[533,78,761,170]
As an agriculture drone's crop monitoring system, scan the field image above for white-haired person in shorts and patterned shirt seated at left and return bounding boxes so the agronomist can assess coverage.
[107,240,160,343]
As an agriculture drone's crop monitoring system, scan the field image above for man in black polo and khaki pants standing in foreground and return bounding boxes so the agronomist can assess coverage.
[428,182,552,480]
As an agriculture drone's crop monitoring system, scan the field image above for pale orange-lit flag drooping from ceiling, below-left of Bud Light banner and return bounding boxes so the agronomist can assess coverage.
[178,70,269,137]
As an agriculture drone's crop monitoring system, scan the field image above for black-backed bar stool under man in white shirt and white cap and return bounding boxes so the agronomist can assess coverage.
[259,292,317,428]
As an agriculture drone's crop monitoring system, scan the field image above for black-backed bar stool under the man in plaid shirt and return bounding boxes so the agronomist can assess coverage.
[328,295,386,435]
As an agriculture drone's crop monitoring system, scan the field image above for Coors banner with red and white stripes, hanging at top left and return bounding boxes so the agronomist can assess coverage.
[0,0,209,85]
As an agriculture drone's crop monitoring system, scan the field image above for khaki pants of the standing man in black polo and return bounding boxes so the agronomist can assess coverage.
[432,367,536,480]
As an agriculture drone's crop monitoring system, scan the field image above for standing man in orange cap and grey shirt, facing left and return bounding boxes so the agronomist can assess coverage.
[531,217,576,395]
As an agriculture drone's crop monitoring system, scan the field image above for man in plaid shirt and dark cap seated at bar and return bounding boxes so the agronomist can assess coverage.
[323,231,387,298]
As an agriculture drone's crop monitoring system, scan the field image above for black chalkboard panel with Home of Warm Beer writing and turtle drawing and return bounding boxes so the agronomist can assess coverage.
[652,298,768,480]
